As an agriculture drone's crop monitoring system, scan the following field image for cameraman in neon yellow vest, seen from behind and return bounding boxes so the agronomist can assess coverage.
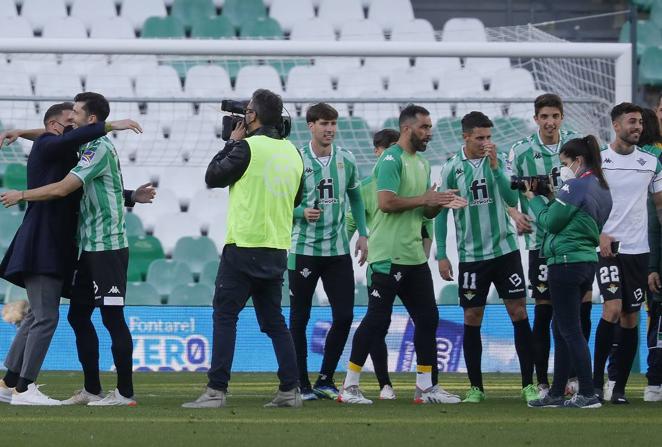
[183,89,303,408]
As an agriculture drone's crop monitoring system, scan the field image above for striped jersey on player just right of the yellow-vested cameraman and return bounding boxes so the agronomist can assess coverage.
[290,143,361,256]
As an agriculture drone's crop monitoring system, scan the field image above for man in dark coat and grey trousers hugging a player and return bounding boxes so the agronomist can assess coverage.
[0,102,155,405]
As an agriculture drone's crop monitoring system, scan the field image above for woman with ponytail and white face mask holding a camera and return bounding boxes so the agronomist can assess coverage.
[525,135,612,408]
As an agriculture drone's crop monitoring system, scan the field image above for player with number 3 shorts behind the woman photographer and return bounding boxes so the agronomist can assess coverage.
[507,93,591,398]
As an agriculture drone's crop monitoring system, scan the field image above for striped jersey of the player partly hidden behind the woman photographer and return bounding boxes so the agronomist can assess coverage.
[507,130,581,250]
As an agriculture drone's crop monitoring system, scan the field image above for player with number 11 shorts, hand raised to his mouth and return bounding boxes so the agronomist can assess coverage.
[435,112,538,403]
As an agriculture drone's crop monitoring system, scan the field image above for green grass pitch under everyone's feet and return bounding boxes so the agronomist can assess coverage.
[0,372,662,447]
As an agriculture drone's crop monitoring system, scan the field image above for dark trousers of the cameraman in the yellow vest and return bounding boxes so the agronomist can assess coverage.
[207,244,299,391]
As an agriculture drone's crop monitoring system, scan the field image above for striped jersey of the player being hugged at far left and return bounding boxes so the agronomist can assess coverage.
[71,136,129,251]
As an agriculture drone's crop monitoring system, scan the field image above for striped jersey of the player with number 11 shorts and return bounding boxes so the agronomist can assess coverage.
[444,148,518,262]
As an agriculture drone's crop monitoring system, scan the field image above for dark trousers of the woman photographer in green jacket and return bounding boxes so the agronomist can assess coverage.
[548,262,595,396]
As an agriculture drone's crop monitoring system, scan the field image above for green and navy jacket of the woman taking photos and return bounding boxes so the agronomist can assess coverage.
[529,173,612,265]
